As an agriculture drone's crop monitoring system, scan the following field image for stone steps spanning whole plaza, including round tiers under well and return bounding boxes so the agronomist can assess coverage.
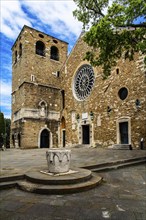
[0,157,146,194]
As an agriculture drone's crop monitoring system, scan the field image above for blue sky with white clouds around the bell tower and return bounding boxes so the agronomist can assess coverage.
[0,0,82,118]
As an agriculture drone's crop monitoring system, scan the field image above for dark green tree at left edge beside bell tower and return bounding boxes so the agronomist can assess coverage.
[0,112,6,148]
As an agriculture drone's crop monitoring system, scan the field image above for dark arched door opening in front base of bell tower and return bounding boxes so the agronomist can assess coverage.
[40,129,50,148]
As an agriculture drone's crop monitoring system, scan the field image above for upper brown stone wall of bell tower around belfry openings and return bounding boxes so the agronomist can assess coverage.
[12,26,68,92]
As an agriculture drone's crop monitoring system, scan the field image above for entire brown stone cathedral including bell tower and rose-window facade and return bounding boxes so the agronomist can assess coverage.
[11,25,146,149]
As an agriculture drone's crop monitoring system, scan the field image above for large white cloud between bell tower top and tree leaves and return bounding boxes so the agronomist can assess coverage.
[22,0,82,36]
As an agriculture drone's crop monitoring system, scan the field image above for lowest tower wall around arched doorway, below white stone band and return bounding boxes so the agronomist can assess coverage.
[12,118,59,149]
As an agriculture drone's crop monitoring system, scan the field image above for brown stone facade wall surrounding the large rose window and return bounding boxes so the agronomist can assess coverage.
[62,34,146,147]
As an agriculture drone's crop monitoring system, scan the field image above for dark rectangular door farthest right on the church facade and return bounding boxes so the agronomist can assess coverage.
[119,122,129,144]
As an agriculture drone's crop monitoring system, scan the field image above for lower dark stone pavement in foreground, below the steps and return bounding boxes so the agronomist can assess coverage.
[0,165,146,220]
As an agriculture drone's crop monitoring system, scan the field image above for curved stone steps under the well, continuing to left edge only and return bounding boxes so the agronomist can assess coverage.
[0,168,102,194]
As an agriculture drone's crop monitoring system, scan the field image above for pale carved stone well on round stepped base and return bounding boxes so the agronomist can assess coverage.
[46,148,71,174]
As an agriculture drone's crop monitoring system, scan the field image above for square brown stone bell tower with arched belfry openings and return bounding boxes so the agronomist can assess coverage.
[11,26,68,148]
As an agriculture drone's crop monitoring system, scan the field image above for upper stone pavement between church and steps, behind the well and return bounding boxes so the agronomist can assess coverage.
[0,147,146,176]
